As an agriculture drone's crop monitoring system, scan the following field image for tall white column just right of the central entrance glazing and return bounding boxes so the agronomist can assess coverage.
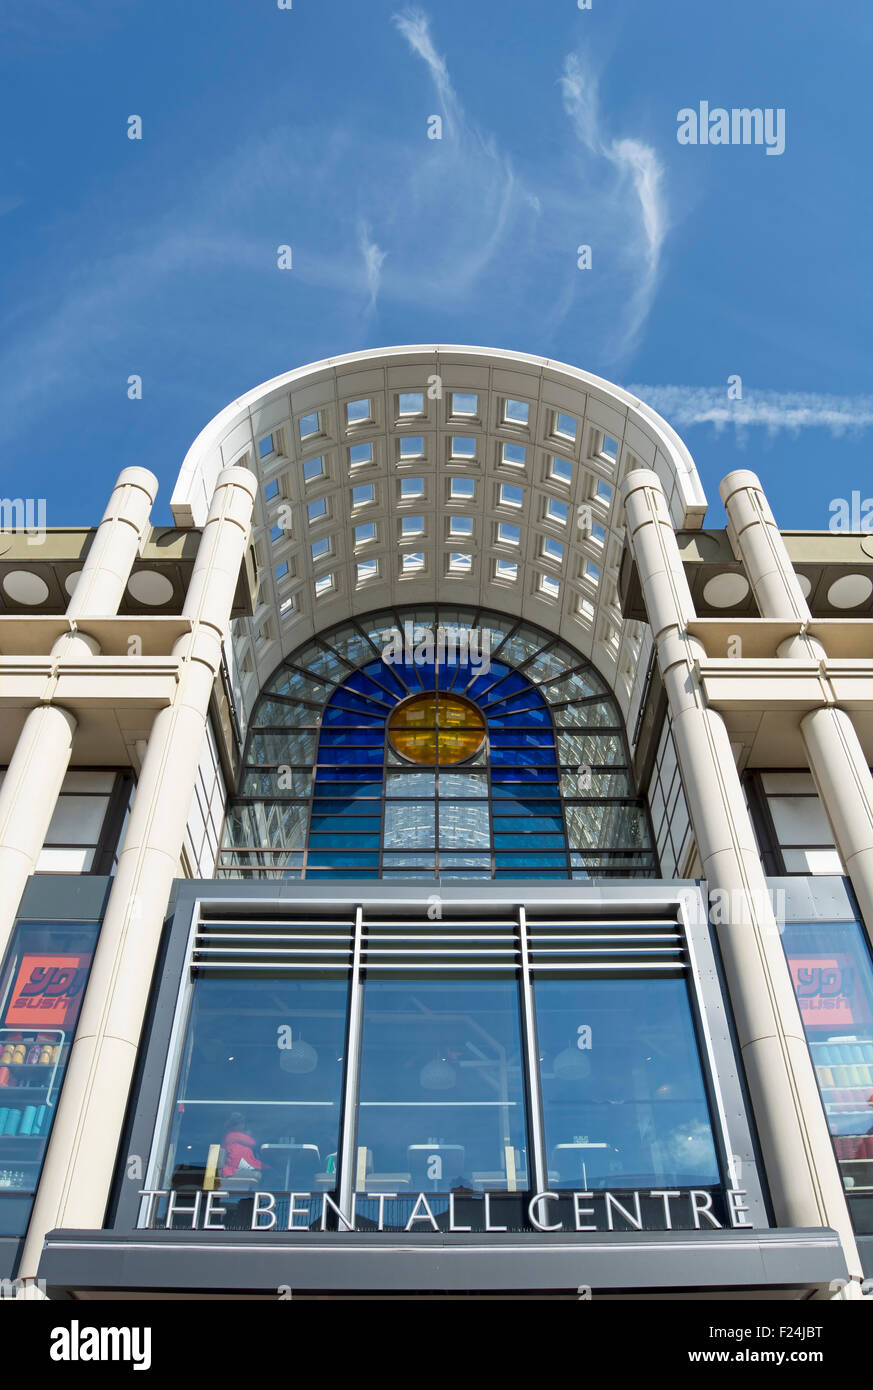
[621,468,860,1275]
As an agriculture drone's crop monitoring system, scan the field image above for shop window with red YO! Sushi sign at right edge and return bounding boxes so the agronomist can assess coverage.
[781,922,873,1234]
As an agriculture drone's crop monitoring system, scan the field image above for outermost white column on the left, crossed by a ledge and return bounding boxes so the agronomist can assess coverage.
[0,468,157,958]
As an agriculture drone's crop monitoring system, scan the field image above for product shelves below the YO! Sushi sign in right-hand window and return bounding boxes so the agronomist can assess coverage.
[812,1036,873,1193]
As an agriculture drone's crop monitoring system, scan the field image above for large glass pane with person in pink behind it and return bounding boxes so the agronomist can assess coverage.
[156,972,348,1229]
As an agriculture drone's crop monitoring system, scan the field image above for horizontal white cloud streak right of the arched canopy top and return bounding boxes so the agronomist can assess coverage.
[627,385,873,435]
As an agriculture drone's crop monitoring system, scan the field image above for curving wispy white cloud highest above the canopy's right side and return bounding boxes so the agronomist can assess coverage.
[560,53,669,357]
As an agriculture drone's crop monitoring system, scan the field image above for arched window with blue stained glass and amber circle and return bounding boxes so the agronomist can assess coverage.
[220,607,658,880]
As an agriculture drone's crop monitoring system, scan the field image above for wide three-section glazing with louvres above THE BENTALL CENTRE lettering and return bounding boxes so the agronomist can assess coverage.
[140,916,730,1232]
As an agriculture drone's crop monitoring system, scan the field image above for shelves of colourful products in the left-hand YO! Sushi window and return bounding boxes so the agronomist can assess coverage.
[0,1029,65,1139]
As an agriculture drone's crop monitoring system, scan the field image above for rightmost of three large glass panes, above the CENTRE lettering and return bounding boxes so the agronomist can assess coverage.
[534,979,721,1191]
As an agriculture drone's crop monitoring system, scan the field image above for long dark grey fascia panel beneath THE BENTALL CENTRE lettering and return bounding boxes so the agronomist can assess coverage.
[39,1227,848,1298]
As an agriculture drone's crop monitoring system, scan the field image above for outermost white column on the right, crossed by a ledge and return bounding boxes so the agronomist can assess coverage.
[720,468,873,941]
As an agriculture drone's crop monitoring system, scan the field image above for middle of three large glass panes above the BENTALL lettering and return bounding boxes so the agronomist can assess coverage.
[354,976,528,1230]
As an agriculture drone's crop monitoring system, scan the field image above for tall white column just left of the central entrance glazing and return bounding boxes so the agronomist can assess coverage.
[21,468,257,1277]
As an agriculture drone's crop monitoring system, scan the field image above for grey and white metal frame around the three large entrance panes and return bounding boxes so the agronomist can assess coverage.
[111,881,770,1230]
